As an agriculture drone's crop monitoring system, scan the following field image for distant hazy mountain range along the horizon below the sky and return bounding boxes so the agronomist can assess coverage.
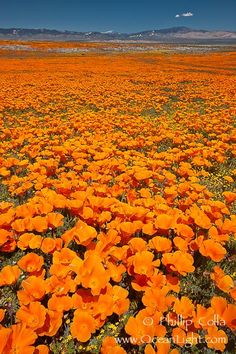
[0,27,236,43]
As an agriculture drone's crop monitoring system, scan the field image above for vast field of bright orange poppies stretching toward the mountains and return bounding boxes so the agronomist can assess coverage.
[0,45,236,354]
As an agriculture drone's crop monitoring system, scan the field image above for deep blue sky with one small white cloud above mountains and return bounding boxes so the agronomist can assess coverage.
[0,0,236,32]
